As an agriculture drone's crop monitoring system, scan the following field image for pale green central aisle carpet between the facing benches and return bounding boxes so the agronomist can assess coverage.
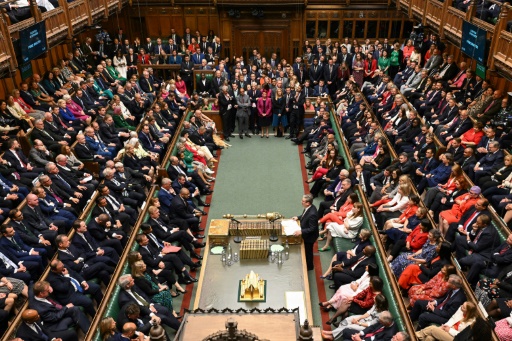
[202,136,322,325]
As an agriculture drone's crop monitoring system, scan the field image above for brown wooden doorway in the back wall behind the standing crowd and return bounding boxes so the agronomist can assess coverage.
[233,25,290,60]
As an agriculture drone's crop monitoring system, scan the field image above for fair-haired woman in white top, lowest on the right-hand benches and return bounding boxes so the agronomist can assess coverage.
[416,302,476,341]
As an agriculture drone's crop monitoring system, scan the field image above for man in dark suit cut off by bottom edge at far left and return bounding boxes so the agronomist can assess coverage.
[16,309,78,341]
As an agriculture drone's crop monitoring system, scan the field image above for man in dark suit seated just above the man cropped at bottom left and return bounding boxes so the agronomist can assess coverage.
[29,281,91,334]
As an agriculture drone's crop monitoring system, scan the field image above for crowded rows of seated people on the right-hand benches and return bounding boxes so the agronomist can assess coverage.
[286,48,512,340]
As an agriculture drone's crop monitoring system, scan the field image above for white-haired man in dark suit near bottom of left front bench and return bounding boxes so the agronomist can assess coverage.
[117,274,180,330]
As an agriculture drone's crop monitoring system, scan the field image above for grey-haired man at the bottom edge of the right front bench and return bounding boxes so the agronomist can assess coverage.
[343,310,398,341]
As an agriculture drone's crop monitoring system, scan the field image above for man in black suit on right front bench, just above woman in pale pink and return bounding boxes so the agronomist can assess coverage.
[329,245,377,290]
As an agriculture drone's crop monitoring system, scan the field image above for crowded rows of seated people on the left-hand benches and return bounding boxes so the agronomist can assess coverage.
[0,29,234,341]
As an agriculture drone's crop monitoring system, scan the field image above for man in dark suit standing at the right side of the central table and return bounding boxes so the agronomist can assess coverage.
[292,194,318,271]
